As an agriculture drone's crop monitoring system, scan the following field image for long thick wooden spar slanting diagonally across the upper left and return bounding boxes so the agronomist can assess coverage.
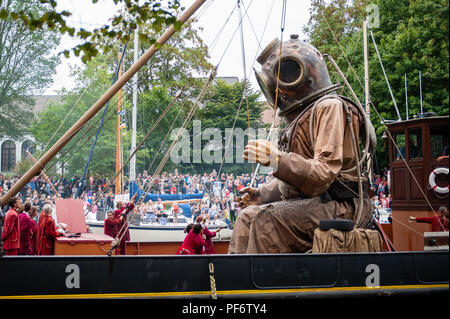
[1,0,206,206]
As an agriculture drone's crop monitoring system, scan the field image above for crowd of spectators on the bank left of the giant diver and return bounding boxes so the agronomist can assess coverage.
[0,169,272,222]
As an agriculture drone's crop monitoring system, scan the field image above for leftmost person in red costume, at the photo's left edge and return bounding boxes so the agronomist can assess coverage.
[2,197,23,255]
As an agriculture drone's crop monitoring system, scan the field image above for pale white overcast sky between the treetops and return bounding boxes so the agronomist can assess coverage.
[44,0,310,95]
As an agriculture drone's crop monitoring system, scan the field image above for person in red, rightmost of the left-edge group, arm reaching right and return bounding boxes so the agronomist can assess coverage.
[36,204,62,255]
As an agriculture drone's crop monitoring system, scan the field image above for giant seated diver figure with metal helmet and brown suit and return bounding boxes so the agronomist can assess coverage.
[229,35,373,254]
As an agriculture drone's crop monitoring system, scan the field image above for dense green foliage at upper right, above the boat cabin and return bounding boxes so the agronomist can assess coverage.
[304,0,449,170]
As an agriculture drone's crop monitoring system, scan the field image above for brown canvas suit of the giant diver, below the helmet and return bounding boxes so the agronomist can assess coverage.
[228,97,372,254]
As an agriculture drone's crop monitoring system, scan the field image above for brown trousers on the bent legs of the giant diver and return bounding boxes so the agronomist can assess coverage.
[228,196,373,254]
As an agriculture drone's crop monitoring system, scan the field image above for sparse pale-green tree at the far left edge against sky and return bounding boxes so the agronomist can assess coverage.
[0,0,59,137]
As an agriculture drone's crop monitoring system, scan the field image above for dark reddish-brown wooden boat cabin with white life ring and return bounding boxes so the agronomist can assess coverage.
[387,116,449,251]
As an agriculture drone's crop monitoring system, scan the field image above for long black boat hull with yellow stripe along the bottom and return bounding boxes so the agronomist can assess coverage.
[0,251,449,299]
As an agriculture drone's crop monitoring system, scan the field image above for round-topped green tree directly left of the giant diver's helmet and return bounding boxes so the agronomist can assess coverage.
[177,79,267,173]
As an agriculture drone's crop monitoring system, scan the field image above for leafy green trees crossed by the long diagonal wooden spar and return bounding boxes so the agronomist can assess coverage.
[29,17,210,177]
